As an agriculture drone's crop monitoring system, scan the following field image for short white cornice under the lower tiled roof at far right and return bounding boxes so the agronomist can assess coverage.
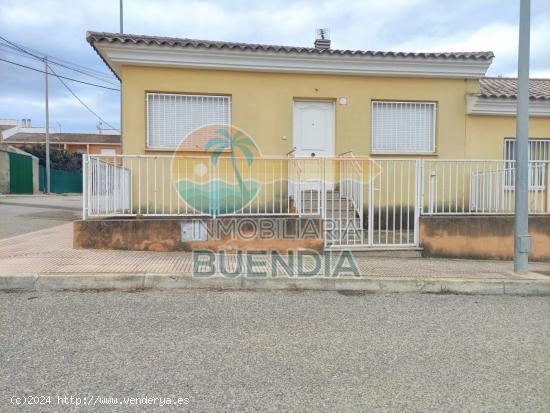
[466,95,550,117]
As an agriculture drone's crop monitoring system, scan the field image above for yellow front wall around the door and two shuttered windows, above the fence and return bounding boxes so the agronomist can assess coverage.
[122,67,492,158]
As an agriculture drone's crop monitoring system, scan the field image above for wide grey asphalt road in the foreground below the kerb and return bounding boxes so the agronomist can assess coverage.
[0,291,550,412]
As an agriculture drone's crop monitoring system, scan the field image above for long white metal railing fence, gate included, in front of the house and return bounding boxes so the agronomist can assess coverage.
[83,153,550,246]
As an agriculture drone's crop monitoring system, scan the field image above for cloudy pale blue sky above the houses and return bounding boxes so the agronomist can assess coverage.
[0,0,550,132]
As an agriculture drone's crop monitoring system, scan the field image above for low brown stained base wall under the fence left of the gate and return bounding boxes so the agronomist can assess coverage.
[73,217,324,253]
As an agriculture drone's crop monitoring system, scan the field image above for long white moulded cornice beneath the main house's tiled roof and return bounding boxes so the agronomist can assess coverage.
[94,42,491,79]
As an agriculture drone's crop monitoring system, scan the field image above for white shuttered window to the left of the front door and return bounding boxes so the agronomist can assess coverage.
[147,93,231,150]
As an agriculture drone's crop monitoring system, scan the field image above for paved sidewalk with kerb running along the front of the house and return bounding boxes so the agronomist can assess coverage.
[0,224,550,295]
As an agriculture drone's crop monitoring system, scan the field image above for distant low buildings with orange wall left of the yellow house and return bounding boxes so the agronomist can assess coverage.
[0,119,121,155]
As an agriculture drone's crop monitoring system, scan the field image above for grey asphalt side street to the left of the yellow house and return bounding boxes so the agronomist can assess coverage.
[0,195,82,239]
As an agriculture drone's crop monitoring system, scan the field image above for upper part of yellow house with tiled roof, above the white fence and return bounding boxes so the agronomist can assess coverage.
[87,32,550,159]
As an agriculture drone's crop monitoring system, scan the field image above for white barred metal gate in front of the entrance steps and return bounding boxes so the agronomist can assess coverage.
[321,157,422,249]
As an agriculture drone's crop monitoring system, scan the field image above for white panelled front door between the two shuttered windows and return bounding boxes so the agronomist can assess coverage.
[293,101,334,157]
